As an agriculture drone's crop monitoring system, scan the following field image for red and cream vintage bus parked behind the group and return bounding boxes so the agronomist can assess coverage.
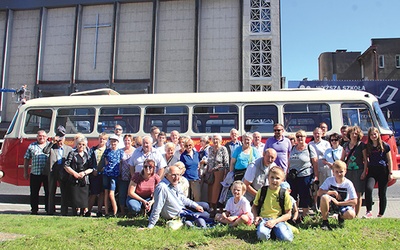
[0,89,400,185]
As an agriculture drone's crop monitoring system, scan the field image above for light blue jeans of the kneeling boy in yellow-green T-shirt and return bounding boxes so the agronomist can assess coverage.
[257,218,293,241]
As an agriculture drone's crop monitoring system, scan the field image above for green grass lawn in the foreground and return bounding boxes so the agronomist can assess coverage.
[0,214,400,250]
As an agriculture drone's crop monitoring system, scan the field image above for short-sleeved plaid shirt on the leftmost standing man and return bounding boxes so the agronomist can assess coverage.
[24,142,49,175]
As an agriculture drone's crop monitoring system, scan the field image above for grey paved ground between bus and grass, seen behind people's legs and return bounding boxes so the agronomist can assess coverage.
[0,180,400,218]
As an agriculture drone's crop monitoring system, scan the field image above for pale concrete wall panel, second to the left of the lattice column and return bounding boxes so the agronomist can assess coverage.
[155,1,195,93]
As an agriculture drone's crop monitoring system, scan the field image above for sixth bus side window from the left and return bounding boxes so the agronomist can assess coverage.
[244,105,278,133]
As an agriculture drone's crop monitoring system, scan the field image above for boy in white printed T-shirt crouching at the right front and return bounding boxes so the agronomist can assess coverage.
[317,160,357,230]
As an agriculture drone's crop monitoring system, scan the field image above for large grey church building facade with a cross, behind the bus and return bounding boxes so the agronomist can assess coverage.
[0,0,281,125]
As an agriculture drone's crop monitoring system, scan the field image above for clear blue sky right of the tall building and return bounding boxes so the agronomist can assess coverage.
[281,0,400,83]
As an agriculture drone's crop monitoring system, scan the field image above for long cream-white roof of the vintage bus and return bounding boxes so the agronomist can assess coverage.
[23,89,377,108]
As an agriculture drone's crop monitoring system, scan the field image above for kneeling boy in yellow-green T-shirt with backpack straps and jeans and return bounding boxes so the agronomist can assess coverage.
[252,166,293,241]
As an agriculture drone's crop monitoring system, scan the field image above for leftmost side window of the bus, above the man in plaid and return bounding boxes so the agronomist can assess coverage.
[24,109,53,134]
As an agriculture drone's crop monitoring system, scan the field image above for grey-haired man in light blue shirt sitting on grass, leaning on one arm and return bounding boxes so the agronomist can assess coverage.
[147,165,210,229]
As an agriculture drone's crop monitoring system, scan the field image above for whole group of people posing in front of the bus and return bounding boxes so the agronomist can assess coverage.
[24,123,392,241]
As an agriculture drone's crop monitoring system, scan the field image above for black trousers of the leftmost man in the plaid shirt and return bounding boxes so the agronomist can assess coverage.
[29,174,49,213]
